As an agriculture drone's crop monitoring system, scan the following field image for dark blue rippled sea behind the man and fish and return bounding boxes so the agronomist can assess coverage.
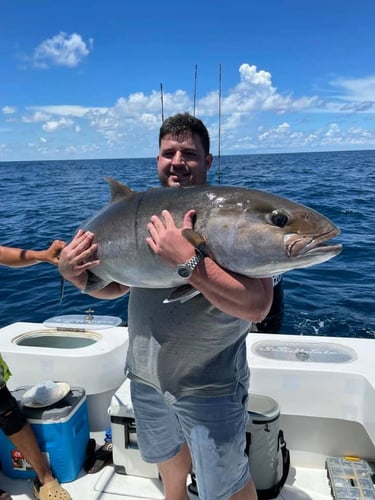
[0,151,375,338]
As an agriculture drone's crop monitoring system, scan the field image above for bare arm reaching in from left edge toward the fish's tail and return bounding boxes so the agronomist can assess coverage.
[0,240,65,267]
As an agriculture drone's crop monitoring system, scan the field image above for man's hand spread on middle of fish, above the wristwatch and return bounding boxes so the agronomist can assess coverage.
[146,210,195,267]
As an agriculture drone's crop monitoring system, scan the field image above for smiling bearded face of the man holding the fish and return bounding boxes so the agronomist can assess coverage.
[157,134,212,187]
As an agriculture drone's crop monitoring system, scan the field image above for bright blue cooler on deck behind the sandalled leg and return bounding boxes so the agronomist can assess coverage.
[0,386,90,483]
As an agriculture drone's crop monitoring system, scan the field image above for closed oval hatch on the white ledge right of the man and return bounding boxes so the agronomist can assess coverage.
[252,340,357,363]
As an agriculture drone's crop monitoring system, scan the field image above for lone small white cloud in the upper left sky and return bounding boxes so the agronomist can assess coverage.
[32,31,93,68]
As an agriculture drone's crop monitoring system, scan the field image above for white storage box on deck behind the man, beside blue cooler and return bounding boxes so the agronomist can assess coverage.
[110,379,159,479]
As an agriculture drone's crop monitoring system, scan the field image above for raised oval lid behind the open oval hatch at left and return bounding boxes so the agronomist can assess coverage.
[43,309,122,330]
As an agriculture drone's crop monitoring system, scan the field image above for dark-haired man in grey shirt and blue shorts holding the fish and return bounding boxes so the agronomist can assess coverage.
[59,113,272,500]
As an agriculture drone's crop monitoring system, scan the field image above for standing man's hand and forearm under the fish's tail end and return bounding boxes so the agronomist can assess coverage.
[59,229,129,299]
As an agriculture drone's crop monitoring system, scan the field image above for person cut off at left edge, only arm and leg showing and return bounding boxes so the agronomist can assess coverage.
[0,240,71,500]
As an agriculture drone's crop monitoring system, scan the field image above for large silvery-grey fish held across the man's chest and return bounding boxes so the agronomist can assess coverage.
[82,178,342,291]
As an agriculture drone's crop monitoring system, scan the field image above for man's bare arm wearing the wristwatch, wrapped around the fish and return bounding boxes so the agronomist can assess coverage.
[147,210,273,323]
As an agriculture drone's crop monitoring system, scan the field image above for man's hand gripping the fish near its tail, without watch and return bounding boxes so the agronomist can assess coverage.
[59,229,100,288]
